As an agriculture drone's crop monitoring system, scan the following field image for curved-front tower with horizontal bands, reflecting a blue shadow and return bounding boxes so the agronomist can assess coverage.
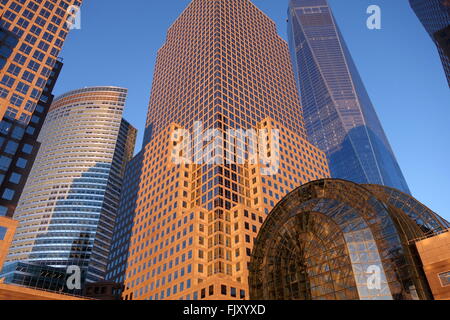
[5,87,136,288]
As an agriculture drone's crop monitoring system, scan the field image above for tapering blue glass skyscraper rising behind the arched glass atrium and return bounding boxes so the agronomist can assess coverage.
[288,0,410,193]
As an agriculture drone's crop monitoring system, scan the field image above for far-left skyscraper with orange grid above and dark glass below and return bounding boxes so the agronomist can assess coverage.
[0,0,82,268]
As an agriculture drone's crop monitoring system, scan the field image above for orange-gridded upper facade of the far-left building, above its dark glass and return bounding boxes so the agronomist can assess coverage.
[0,0,82,123]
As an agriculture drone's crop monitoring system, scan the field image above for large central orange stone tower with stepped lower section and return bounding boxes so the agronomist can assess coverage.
[119,0,329,300]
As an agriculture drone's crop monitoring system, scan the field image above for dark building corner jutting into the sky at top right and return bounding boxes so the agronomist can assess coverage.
[409,0,450,86]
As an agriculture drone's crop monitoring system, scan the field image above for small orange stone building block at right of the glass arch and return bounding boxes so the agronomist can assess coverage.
[416,229,450,300]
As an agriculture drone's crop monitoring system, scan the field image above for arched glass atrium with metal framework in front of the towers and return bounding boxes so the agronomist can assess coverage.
[249,179,450,300]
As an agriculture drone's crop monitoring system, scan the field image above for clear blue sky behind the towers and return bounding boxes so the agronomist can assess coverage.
[55,0,450,219]
